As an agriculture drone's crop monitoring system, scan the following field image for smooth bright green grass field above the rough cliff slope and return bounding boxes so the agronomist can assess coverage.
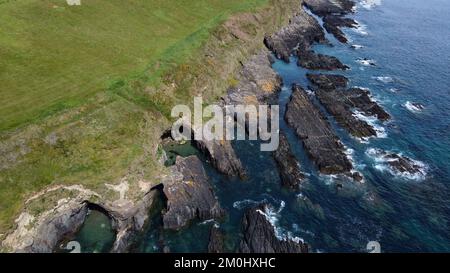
[0,0,266,134]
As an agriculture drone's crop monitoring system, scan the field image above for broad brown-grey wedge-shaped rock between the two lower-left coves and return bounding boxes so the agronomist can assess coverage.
[163,156,225,230]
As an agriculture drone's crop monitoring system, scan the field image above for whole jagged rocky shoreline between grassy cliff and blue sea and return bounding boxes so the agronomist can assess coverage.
[2,0,417,253]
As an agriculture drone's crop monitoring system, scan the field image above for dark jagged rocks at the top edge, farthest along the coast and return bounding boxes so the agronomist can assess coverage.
[303,0,358,43]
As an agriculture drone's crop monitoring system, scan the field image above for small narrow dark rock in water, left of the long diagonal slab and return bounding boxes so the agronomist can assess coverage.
[273,132,305,190]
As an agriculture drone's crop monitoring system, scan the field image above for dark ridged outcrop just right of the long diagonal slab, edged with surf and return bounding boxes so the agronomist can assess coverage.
[307,74,389,138]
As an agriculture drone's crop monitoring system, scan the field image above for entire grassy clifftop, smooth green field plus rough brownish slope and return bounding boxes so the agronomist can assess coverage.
[0,0,300,240]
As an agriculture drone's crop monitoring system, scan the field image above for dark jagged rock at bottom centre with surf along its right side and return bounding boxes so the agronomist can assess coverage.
[239,204,308,253]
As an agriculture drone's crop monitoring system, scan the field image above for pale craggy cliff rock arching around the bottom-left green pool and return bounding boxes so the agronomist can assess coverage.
[2,181,162,253]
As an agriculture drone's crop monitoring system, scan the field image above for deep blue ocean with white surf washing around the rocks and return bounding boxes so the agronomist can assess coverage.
[73,0,450,252]
